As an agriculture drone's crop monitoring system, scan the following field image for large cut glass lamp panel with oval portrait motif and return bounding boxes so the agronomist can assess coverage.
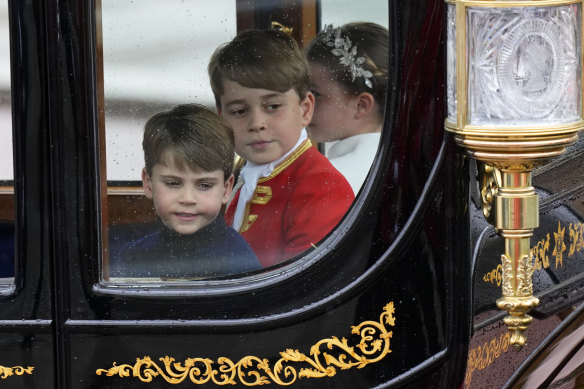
[466,5,582,127]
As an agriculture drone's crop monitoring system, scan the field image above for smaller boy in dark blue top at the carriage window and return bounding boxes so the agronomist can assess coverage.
[111,104,261,279]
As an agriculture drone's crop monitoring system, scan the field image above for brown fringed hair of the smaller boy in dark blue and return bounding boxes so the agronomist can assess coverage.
[142,104,235,180]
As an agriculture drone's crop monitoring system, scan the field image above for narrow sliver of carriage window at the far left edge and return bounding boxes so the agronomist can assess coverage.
[0,0,14,289]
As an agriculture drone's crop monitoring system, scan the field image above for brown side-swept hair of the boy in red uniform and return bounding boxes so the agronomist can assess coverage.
[208,30,310,107]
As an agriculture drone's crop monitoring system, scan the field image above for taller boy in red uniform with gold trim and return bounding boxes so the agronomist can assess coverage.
[208,30,354,266]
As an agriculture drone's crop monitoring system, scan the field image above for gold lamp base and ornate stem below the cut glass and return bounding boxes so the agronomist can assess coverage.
[446,122,583,350]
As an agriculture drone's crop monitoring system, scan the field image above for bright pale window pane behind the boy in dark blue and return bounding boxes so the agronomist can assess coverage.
[101,0,236,182]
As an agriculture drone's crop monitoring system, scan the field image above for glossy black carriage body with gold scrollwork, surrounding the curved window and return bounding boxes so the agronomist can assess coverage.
[0,0,584,388]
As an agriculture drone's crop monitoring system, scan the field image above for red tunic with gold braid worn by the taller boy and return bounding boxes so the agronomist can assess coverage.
[225,140,355,266]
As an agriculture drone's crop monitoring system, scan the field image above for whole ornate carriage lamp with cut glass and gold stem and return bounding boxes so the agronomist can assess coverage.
[445,0,584,350]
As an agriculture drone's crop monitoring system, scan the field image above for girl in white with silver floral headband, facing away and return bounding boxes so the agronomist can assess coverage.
[306,22,389,194]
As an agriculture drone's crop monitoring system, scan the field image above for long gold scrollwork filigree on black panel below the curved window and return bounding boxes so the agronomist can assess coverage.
[95,302,395,386]
